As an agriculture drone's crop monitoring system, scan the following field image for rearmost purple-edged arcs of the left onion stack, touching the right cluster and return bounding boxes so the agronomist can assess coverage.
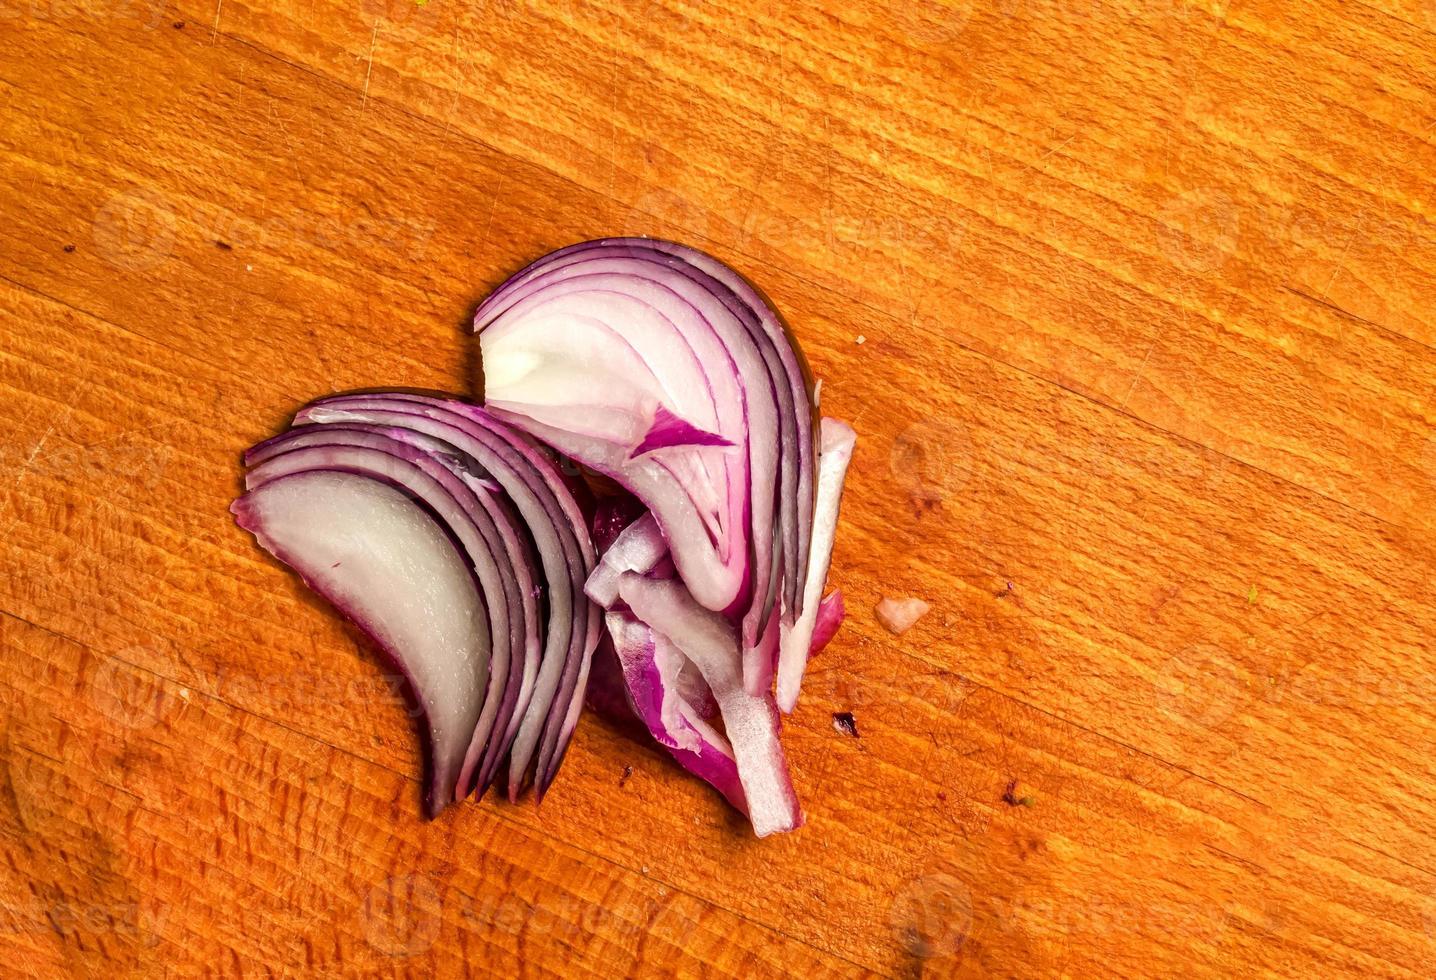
[296,394,600,799]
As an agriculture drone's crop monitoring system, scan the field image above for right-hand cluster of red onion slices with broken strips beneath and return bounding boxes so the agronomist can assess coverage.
[474,239,854,836]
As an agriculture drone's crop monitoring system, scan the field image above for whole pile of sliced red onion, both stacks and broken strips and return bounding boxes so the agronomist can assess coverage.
[236,239,854,836]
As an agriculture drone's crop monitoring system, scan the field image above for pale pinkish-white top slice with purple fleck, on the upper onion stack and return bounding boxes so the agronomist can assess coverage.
[481,270,777,611]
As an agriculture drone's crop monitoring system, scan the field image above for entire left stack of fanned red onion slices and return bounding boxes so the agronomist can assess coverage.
[234,394,600,815]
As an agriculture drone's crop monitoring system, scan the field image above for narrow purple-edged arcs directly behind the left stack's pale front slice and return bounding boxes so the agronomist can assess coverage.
[246,424,537,799]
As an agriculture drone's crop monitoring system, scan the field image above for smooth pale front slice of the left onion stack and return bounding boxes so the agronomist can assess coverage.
[233,470,490,816]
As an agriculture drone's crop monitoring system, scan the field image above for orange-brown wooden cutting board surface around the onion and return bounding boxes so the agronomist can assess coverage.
[0,0,1436,979]
